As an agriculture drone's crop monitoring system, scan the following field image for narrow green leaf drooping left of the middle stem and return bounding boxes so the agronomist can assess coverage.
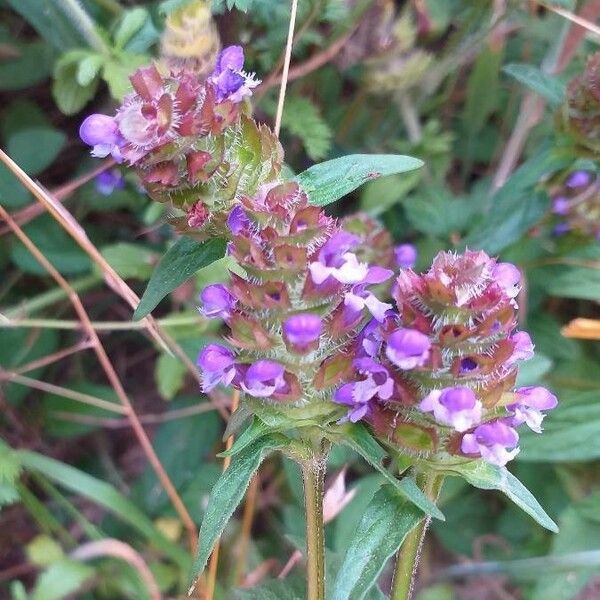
[190,436,284,584]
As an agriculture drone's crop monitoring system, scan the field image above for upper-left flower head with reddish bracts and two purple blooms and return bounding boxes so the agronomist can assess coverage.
[80,46,282,223]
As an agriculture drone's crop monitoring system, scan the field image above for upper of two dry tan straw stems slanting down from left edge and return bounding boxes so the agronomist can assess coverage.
[0,150,227,418]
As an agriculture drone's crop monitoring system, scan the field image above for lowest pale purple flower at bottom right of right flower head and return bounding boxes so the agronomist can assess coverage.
[460,421,519,467]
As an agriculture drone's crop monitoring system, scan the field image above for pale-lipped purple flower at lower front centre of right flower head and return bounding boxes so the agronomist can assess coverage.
[419,387,482,432]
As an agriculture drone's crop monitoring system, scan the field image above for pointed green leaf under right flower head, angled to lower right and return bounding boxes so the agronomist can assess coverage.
[449,460,558,532]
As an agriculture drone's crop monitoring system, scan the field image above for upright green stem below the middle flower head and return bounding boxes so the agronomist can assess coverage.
[301,446,327,600]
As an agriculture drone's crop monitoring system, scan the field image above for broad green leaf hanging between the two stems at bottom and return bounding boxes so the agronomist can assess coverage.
[333,484,423,600]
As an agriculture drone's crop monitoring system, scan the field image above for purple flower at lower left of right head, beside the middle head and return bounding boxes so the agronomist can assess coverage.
[333,358,394,423]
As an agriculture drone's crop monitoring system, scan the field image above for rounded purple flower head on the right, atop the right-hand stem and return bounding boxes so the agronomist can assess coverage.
[334,251,557,465]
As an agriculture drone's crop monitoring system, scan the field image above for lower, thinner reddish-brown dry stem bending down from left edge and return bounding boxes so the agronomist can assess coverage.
[0,204,197,552]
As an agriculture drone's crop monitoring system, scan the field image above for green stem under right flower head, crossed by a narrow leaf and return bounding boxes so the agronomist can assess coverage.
[390,474,444,600]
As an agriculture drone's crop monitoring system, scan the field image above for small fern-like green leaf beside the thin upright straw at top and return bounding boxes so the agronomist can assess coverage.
[281,96,333,160]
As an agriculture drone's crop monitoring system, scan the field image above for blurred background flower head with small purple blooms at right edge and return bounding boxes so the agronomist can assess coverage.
[552,171,600,239]
